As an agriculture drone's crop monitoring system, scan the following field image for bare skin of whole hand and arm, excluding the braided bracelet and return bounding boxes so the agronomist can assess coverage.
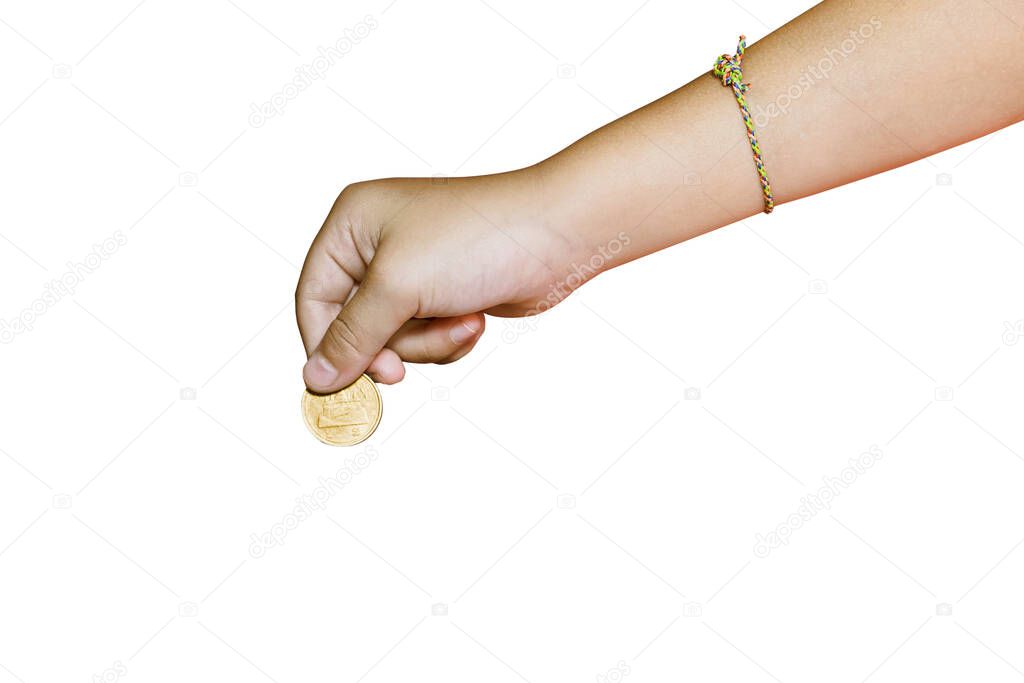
[296,0,1024,392]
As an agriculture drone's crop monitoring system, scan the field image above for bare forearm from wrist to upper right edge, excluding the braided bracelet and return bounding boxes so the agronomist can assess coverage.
[537,0,1024,266]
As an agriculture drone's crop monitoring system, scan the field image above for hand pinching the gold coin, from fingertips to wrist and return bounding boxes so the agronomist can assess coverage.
[296,169,574,392]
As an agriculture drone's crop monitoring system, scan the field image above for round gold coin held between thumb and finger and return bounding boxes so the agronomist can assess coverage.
[302,375,383,445]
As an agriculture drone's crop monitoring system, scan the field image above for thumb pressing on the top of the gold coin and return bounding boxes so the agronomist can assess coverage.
[302,273,416,393]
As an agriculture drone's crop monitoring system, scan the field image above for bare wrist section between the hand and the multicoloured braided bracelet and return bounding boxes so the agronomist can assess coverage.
[538,78,763,270]
